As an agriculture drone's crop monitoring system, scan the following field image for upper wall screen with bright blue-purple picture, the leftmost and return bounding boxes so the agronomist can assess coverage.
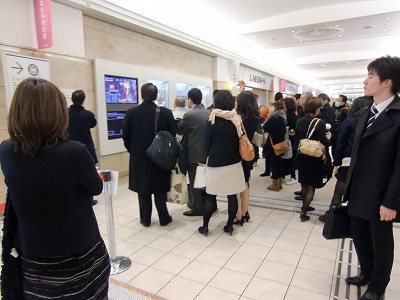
[104,75,138,104]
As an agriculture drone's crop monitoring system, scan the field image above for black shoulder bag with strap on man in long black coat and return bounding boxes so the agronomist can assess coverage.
[146,106,181,170]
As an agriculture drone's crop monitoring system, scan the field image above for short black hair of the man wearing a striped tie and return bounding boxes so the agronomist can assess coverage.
[367,55,400,95]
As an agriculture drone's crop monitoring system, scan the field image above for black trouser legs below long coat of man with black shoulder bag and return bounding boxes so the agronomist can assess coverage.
[138,192,169,225]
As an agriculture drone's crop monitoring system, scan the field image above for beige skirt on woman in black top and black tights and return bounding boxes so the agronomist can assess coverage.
[206,162,246,196]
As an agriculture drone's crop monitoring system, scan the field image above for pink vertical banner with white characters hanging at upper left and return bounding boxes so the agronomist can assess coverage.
[33,0,53,49]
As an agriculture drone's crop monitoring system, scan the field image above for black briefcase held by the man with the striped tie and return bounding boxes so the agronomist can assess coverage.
[322,203,350,240]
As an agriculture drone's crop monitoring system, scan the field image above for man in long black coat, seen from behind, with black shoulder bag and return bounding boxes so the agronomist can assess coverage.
[122,83,176,227]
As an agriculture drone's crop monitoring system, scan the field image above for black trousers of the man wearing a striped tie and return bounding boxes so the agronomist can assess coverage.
[351,217,394,294]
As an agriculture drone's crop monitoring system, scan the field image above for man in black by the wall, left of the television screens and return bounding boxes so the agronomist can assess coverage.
[68,90,98,205]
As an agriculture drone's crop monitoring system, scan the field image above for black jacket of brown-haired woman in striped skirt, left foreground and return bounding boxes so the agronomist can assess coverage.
[0,140,103,257]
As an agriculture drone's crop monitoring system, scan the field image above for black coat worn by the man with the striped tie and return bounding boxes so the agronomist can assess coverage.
[344,95,400,221]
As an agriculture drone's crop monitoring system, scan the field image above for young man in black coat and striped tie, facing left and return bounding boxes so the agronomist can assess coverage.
[344,56,400,300]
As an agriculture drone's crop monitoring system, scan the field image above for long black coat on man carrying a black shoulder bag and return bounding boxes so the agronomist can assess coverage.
[122,101,176,194]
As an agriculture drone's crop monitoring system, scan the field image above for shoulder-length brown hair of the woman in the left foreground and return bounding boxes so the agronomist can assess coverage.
[8,78,68,157]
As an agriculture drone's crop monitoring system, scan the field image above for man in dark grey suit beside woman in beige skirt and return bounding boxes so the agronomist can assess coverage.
[177,88,209,216]
